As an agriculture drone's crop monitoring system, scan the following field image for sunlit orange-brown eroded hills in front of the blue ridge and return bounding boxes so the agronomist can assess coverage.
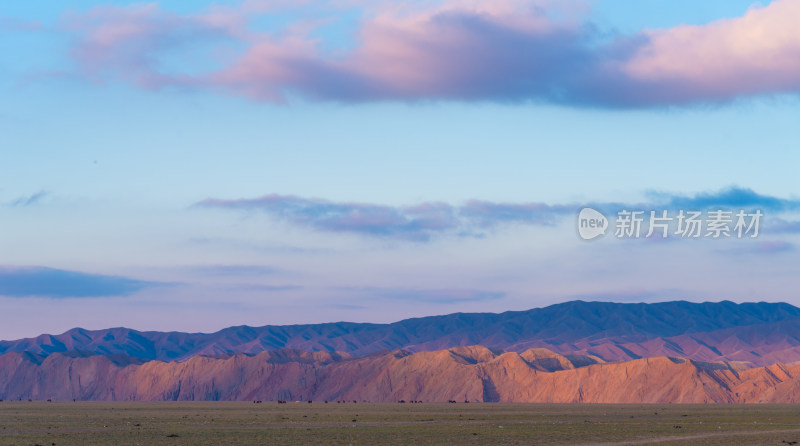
[0,346,800,403]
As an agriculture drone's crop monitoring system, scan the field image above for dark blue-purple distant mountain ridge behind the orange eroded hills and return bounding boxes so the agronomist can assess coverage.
[0,301,800,366]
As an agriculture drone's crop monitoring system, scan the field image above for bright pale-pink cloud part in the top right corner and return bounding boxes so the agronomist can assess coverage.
[621,0,800,101]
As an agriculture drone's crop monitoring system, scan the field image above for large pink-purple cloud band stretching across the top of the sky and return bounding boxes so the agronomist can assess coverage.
[54,0,800,107]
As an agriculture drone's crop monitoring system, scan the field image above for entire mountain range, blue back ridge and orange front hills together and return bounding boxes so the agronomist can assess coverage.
[0,301,800,402]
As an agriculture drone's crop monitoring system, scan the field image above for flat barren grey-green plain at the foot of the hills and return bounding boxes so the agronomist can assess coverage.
[0,401,800,446]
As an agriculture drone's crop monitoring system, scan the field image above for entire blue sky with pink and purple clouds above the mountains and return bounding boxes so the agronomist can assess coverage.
[0,0,800,339]
